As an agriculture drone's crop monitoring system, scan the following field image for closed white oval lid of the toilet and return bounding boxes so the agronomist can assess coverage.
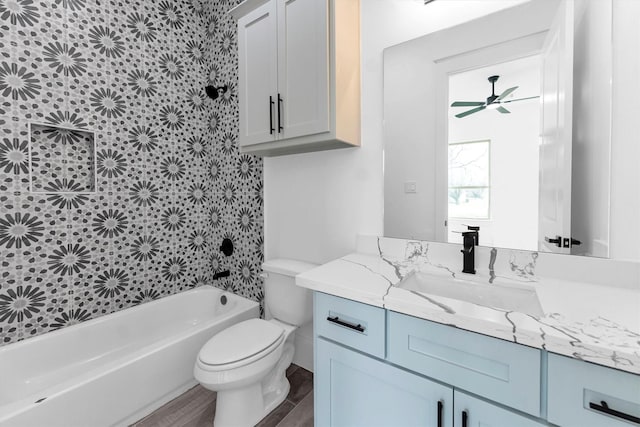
[198,319,284,365]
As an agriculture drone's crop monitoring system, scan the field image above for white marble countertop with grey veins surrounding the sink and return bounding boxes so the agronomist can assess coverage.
[296,237,640,374]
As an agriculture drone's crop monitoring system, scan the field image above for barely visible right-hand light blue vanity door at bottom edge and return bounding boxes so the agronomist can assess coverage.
[453,391,547,427]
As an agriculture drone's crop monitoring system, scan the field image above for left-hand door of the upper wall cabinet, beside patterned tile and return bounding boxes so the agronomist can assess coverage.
[238,1,278,146]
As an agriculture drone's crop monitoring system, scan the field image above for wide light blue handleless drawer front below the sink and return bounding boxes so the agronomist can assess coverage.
[387,312,540,417]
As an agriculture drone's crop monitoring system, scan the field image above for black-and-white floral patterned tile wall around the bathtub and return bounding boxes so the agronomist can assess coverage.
[0,0,263,345]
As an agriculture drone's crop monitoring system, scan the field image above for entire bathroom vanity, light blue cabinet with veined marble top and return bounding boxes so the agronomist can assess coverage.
[297,238,640,427]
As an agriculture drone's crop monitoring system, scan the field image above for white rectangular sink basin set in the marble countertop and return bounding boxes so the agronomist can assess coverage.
[397,271,544,318]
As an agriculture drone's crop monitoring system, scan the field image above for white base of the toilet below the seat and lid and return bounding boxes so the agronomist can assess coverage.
[213,342,294,427]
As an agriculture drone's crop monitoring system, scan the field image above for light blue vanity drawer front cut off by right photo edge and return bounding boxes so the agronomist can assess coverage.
[547,354,640,427]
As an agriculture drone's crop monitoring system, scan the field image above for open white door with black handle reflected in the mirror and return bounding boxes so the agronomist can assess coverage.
[538,0,574,254]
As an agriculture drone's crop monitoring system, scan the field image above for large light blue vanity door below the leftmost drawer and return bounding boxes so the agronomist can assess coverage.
[314,338,453,427]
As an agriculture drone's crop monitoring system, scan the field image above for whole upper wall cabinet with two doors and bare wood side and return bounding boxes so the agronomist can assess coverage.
[231,0,360,156]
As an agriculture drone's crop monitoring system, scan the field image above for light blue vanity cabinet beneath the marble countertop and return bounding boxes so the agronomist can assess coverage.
[314,292,640,427]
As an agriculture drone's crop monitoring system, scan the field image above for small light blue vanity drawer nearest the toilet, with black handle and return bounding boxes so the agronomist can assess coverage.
[313,292,385,358]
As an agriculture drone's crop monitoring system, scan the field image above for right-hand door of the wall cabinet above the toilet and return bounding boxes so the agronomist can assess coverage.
[277,0,329,138]
